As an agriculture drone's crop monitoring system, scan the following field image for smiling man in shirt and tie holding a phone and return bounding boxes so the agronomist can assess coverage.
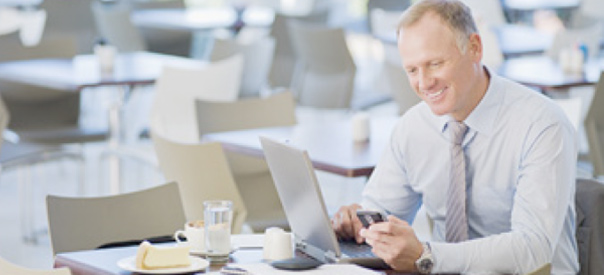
[333,0,579,274]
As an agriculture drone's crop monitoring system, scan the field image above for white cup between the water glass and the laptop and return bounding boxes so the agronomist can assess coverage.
[262,227,294,261]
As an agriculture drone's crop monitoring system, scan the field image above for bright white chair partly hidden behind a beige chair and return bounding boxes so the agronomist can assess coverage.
[150,55,243,143]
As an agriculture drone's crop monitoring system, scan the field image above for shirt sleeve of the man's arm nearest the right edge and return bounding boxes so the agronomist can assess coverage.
[430,123,576,274]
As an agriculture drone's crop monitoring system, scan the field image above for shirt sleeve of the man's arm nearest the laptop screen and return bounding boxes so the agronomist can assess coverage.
[361,123,421,223]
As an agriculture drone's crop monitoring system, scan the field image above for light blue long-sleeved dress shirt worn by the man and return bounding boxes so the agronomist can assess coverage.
[361,70,579,274]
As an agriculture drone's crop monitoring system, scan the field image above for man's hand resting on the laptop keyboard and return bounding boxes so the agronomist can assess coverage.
[331,203,365,243]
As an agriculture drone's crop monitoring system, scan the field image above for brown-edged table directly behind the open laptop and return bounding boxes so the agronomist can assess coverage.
[202,112,397,177]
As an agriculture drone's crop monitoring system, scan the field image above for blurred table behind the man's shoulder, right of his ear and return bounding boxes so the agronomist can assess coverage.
[498,56,604,91]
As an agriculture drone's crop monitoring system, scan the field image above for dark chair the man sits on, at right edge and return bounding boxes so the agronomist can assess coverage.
[575,179,604,275]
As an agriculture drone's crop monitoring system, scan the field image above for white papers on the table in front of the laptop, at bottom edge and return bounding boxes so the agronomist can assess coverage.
[229,263,380,275]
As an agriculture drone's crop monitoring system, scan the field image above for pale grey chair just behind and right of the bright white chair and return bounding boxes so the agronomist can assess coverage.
[210,37,275,97]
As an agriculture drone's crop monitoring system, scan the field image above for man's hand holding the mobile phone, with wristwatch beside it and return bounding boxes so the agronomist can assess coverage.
[360,215,423,272]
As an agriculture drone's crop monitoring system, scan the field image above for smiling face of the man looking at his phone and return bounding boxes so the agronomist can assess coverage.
[398,12,482,121]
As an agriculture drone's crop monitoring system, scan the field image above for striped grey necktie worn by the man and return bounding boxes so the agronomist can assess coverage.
[445,121,468,242]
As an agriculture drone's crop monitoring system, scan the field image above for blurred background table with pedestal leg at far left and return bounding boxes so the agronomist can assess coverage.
[0,52,205,194]
